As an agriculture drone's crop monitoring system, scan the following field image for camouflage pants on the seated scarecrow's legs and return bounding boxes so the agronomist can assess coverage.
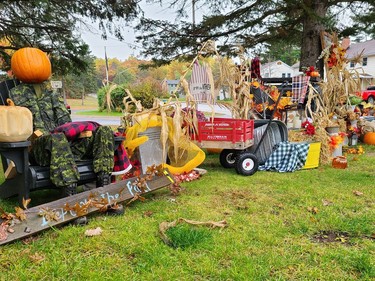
[31,126,114,187]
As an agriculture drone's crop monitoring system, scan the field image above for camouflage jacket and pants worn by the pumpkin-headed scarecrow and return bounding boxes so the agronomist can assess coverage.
[10,83,114,187]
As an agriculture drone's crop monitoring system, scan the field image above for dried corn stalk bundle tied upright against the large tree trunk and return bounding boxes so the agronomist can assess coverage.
[305,33,360,164]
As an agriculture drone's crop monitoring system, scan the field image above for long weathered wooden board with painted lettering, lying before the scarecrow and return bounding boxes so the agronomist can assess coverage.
[0,171,174,245]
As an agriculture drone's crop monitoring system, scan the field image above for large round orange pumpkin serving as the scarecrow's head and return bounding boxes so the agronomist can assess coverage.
[11,47,52,83]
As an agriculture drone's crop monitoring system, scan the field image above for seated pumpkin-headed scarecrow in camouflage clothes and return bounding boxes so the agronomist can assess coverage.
[10,48,114,196]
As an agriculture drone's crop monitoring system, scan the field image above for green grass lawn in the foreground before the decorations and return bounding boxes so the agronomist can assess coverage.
[0,146,375,280]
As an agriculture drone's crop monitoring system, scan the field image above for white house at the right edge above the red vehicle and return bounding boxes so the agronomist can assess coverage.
[346,39,375,90]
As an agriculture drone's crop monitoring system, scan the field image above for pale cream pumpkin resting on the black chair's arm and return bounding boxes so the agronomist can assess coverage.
[0,101,33,142]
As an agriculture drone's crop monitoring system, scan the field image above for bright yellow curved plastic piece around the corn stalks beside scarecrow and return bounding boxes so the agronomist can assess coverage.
[124,114,206,174]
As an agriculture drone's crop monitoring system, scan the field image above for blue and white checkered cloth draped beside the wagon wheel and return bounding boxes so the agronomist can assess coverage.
[258,141,310,172]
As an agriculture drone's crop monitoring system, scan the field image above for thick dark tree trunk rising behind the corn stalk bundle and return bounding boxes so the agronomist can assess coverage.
[300,1,328,77]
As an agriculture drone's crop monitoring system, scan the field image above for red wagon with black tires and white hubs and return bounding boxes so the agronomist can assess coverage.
[191,118,259,176]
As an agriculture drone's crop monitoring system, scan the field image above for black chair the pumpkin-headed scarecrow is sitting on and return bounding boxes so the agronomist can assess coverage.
[0,80,124,206]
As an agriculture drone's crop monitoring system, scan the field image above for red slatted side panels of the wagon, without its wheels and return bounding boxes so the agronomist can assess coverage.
[192,118,254,143]
